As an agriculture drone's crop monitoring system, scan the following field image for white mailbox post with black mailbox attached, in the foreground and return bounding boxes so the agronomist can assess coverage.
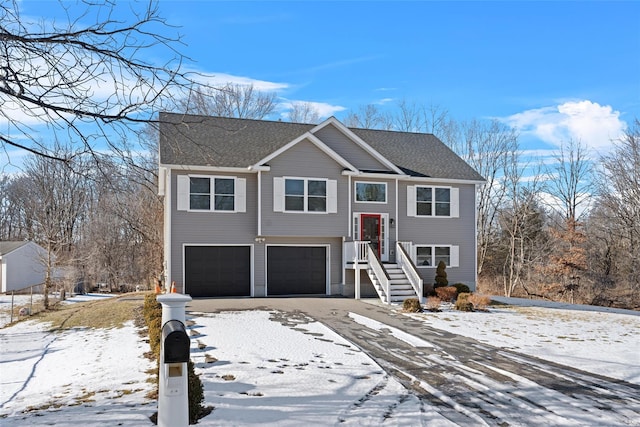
[157,294,191,427]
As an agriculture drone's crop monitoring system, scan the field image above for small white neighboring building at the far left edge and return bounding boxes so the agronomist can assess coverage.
[0,242,47,293]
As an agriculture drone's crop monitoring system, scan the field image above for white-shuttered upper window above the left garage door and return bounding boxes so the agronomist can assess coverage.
[177,175,246,212]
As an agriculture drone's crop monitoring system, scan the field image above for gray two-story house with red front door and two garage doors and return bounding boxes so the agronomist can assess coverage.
[159,113,484,302]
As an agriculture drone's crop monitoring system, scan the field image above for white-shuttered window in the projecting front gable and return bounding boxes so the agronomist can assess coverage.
[273,177,337,213]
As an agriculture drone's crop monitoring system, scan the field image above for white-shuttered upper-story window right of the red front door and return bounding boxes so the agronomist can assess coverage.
[407,185,459,218]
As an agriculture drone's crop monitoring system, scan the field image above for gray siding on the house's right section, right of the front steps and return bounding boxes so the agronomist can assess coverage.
[396,181,476,285]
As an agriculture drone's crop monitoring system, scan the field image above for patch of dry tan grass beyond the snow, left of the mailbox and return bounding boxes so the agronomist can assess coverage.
[31,298,142,329]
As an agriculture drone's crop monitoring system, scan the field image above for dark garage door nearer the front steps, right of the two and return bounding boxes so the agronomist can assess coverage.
[267,246,327,295]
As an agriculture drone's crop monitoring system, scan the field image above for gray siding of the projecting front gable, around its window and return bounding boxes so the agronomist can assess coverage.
[260,137,349,237]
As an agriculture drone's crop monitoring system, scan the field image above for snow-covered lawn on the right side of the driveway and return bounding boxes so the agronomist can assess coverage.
[404,297,640,384]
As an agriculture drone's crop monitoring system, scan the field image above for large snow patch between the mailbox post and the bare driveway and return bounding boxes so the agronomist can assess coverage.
[192,311,430,426]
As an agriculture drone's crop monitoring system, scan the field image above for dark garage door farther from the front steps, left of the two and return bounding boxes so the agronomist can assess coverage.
[184,246,251,297]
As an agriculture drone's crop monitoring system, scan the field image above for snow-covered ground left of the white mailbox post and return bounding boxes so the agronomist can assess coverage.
[0,321,155,426]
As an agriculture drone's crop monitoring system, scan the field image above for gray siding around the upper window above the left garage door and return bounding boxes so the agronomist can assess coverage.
[169,171,258,289]
